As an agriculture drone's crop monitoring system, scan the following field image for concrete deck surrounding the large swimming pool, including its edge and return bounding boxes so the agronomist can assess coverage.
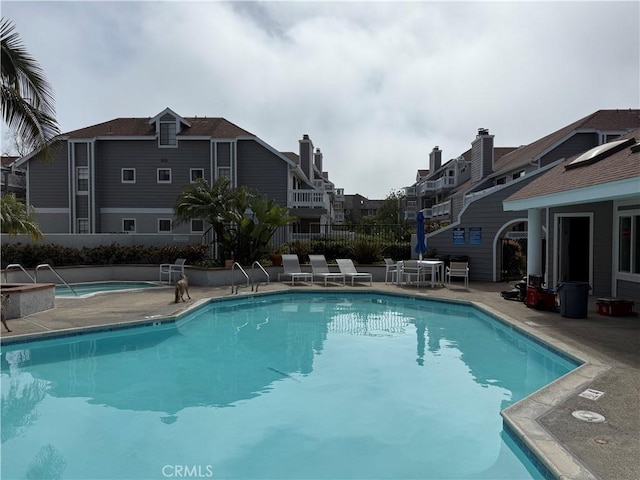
[1,282,640,480]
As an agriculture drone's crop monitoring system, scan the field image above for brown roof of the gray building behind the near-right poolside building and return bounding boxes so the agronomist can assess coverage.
[493,109,640,176]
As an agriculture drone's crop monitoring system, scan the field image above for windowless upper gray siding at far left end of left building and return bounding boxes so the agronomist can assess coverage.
[27,145,69,208]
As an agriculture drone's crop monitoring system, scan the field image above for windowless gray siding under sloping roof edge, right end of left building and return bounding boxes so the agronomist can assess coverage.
[238,140,289,207]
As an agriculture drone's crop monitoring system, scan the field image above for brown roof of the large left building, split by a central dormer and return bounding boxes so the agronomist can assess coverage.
[62,117,255,139]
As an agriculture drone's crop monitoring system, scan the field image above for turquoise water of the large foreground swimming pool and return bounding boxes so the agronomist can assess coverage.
[1,292,576,479]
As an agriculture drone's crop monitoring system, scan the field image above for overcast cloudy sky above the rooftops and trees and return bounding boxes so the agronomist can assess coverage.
[2,0,640,199]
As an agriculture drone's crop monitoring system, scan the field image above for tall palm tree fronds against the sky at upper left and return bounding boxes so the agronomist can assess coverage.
[0,18,60,156]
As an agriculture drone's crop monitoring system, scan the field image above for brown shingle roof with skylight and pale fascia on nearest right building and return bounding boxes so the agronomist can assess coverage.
[504,129,640,210]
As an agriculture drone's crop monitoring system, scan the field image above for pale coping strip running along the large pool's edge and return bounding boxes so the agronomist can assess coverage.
[0,286,611,480]
